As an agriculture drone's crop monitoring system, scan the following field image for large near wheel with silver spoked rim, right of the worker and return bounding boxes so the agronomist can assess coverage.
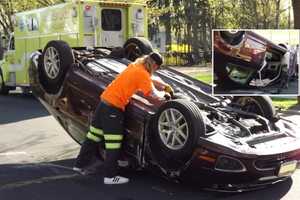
[150,100,205,170]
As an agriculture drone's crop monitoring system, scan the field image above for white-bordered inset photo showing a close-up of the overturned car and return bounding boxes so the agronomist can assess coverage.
[212,29,300,96]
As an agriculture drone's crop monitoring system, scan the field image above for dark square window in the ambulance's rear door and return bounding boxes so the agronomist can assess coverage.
[101,9,122,31]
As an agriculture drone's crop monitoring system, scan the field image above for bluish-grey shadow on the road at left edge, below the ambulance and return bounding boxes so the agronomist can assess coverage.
[0,93,49,124]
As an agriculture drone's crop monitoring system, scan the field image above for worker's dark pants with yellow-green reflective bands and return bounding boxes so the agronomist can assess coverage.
[75,102,124,177]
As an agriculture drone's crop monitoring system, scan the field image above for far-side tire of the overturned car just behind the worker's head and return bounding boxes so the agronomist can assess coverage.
[123,37,153,61]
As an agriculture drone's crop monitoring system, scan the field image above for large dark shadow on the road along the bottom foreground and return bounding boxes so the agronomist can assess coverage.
[0,159,292,200]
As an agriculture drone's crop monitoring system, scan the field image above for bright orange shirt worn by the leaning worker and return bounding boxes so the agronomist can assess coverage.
[100,63,152,110]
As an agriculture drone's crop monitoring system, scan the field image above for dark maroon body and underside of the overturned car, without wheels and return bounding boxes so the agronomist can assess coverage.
[30,50,300,190]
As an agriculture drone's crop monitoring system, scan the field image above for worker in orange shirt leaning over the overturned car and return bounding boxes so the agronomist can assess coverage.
[73,52,173,184]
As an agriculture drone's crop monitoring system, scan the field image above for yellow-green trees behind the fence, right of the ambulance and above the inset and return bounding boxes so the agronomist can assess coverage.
[148,0,291,65]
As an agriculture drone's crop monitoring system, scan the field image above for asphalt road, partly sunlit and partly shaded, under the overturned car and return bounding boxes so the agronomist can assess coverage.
[0,93,300,200]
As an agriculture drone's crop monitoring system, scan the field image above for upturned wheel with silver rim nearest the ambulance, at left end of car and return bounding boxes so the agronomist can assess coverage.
[39,40,75,94]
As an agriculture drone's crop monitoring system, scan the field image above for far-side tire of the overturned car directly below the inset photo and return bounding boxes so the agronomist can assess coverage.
[232,96,276,120]
